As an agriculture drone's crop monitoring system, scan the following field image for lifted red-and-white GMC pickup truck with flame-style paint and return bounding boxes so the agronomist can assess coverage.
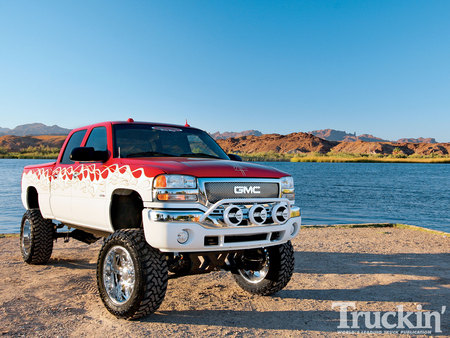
[20,119,301,319]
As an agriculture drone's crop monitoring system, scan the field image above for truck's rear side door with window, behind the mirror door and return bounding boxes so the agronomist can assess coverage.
[50,129,86,222]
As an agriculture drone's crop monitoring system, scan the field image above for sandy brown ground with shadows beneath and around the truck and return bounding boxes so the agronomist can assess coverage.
[0,228,450,337]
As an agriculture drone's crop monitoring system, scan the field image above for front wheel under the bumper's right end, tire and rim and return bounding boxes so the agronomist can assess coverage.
[233,241,294,296]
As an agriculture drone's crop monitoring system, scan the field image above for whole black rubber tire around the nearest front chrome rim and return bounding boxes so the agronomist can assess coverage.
[97,229,168,319]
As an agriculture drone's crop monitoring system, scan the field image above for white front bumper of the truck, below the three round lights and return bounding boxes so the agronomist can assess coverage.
[142,203,301,252]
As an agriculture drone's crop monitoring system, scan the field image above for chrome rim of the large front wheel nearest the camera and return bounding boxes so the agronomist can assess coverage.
[103,246,135,305]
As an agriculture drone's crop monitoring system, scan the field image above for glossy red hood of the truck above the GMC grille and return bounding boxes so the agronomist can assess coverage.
[120,157,289,178]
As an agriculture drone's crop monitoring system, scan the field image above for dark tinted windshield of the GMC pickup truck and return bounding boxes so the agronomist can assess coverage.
[113,123,229,160]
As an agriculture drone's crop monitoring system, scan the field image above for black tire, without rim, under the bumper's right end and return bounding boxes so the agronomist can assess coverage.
[232,241,295,296]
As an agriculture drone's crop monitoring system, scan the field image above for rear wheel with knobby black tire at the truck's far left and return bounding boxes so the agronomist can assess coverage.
[20,209,54,264]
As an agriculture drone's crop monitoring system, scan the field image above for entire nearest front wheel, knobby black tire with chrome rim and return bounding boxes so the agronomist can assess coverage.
[97,229,168,319]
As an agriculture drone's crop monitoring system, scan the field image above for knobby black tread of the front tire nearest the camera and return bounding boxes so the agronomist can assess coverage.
[97,229,168,319]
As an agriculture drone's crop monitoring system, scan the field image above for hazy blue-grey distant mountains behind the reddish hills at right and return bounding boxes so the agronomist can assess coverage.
[309,129,436,143]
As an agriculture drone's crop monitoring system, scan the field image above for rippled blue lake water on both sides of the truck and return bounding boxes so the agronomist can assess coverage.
[0,159,450,233]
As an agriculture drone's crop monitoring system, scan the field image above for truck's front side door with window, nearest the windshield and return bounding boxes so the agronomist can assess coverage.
[71,126,110,231]
